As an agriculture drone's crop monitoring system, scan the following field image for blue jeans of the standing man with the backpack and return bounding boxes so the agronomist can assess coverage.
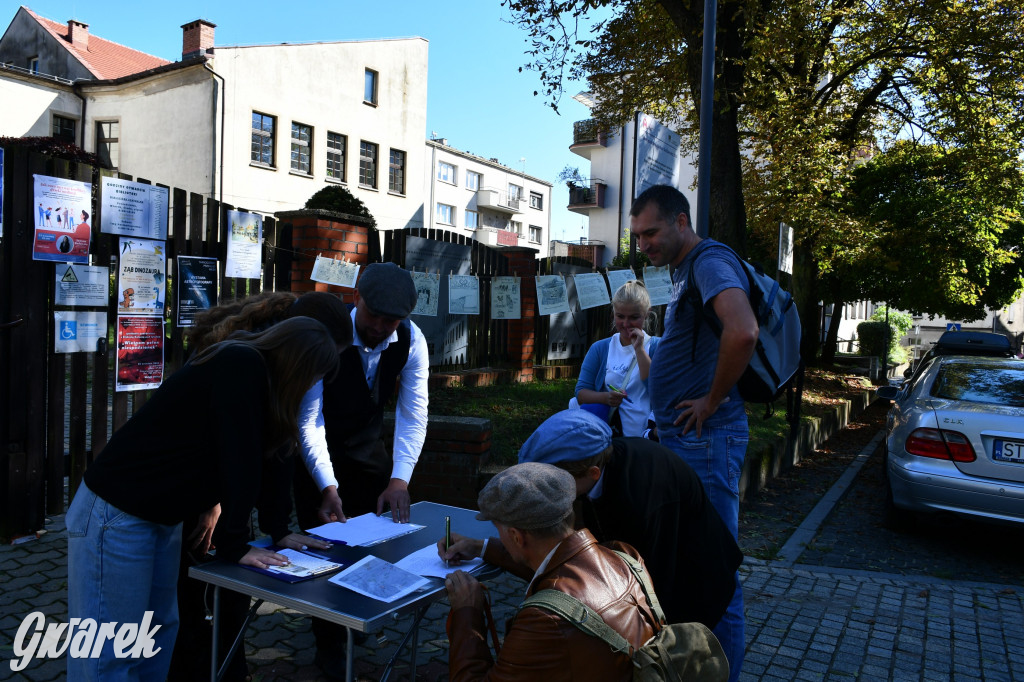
[662,419,750,682]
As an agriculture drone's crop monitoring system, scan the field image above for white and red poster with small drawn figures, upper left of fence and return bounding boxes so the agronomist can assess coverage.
[32,175,92,263]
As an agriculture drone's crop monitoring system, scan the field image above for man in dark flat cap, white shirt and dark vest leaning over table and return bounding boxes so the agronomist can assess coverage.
[294,263,430,678]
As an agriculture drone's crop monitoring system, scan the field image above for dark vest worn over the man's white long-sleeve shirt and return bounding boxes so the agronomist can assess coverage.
[324,319,412,470]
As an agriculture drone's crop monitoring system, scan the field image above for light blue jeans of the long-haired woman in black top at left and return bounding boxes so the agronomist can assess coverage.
[66,483,181,682]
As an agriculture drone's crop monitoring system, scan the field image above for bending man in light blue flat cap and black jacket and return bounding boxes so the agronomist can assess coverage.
[442,410,742,629]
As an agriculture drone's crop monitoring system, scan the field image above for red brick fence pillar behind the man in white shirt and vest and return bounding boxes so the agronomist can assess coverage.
[274,209,377,303]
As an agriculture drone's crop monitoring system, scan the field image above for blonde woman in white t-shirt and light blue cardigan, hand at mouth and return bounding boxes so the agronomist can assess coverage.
[575,280,659,436]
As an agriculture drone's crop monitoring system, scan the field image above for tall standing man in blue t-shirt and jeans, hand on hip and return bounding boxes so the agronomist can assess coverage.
[630,185,758,681]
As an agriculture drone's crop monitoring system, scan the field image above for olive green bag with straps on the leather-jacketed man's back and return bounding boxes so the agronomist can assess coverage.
[517,552,729,682]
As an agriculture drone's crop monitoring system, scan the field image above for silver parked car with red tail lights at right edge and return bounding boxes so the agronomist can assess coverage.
[878,355,1024,523]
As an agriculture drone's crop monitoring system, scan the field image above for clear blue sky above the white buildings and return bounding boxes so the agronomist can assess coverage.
[19,0,589,241]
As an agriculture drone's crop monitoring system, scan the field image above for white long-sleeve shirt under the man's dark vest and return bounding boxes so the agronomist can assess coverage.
[299,308,430,492]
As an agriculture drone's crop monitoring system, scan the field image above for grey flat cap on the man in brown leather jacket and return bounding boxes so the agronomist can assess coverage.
[476,462,575,530]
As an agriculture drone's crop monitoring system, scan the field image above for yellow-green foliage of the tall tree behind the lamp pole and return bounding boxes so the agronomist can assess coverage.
[505,0,1024,357]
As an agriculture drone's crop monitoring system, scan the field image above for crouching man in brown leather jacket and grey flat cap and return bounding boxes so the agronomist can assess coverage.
[446,463,659,682]
